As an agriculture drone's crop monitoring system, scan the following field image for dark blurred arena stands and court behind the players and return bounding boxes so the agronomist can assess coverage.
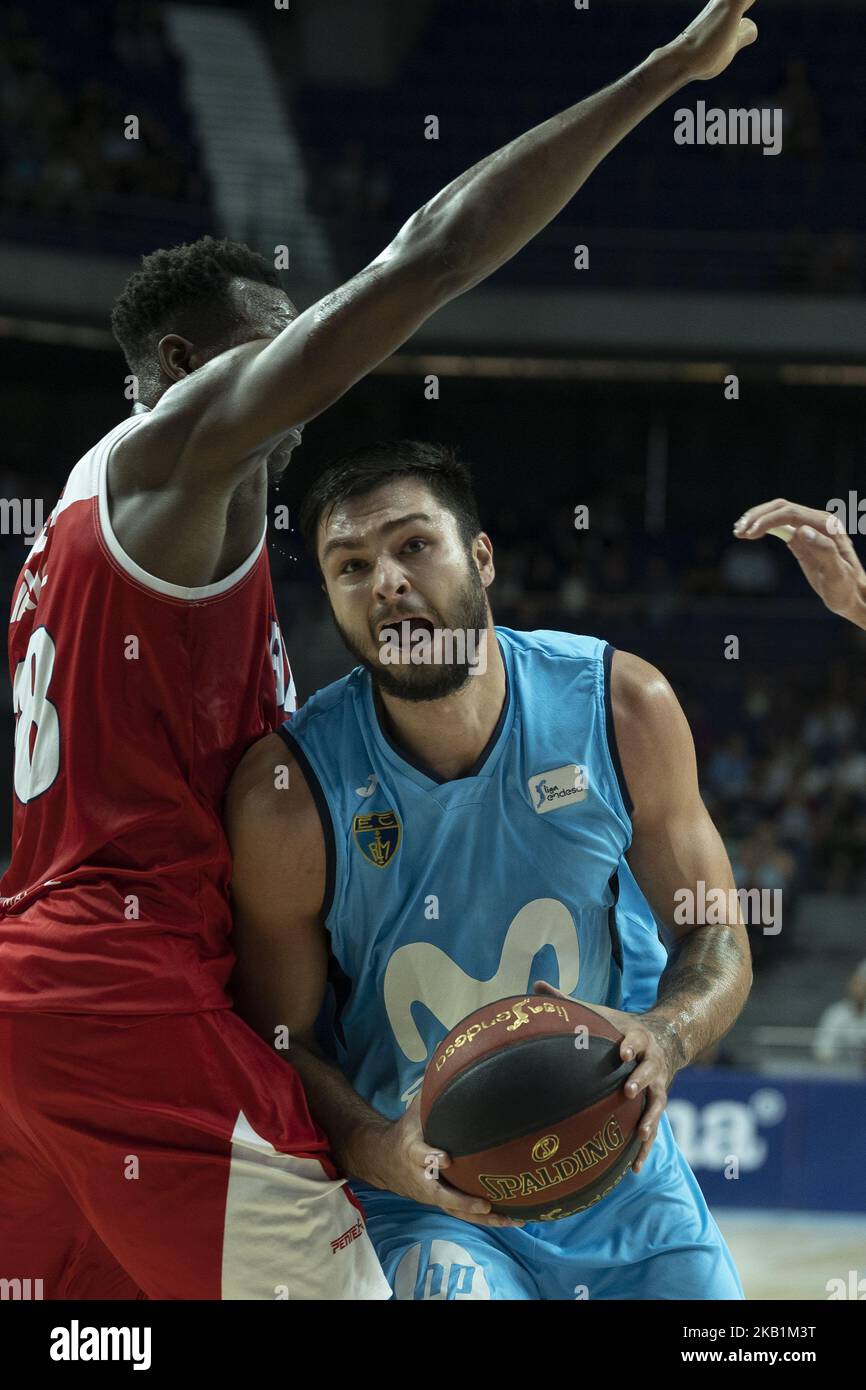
[0,0,866,1321]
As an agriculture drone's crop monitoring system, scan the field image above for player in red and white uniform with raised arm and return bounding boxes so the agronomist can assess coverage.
[0,0,755,1298]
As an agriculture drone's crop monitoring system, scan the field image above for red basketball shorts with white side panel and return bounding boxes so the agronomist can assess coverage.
[0,1009,391,1300]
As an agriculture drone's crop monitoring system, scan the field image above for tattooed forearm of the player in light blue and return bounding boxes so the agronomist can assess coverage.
[649,926,752,1070]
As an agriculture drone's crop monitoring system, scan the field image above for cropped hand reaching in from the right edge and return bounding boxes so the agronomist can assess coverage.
[734,498,866,630]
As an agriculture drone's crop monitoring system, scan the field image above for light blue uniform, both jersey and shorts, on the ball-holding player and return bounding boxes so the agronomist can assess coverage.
[281,627,742,1298]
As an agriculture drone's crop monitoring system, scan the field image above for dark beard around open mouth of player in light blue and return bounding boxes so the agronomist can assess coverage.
[331,555,489,701]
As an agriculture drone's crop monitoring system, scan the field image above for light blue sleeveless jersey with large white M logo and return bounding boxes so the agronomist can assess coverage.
[284,628,666,1119]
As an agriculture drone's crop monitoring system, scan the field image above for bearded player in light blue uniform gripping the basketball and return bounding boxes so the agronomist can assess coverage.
[227,441,751,1300]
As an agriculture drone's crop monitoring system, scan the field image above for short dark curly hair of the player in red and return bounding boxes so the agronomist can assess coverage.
[111,236,281,377]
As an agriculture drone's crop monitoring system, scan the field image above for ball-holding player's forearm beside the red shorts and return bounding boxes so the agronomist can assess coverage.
[288,1038,391,1182]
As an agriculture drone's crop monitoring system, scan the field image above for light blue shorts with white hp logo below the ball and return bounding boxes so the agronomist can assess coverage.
[352,1115,744,1300]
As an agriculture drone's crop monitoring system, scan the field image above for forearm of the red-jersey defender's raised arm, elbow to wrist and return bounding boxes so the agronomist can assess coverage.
[398,44,688,292]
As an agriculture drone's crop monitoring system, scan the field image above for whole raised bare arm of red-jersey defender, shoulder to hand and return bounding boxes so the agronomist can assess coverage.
[143,0,758,487]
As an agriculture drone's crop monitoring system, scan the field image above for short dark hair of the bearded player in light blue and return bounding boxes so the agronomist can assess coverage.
[299,439,481,555]
